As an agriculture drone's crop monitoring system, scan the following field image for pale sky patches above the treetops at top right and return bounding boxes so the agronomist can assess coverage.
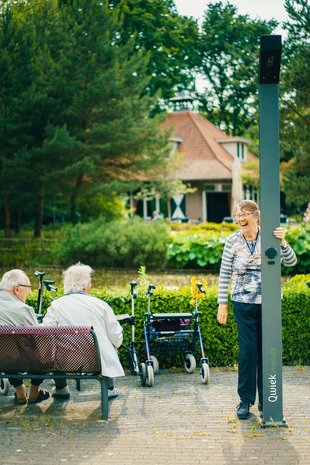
[174,0,287,34]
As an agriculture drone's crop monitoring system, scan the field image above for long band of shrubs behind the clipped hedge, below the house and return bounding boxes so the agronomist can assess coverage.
[0,218,310,274]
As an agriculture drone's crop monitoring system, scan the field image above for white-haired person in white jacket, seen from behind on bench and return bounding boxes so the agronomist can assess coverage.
[42,263,125,398]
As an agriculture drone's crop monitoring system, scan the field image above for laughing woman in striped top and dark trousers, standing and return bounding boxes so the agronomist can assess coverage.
[217,200,296,419]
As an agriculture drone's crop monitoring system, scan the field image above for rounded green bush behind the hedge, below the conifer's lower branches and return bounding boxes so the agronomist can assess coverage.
[60,218,168,268]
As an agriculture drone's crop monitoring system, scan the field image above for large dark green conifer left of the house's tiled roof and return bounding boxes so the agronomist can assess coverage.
[57,0,171,223]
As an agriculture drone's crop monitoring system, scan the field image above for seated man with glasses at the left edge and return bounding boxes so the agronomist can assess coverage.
[0,270,50,404]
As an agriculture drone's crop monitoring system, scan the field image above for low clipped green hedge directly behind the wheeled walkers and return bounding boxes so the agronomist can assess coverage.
[28,275,310,367]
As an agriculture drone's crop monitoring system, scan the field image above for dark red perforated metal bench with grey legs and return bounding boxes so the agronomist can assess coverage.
[0,325,109,420]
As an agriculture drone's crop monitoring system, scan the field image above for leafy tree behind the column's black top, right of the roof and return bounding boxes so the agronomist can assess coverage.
[198,1,277,135]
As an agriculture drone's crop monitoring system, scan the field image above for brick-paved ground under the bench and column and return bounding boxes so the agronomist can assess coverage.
[0,367,310,465]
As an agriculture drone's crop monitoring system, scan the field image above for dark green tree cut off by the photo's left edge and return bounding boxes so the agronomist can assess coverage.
[0,1,41,235]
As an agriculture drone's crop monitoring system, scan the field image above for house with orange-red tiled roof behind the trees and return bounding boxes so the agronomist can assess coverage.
[132,109,257,223]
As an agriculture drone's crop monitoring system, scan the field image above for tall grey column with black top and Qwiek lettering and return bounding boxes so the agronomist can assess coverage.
[259,35,286,426]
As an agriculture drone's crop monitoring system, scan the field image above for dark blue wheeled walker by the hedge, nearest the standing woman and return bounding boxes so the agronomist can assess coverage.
[141,283,210,387]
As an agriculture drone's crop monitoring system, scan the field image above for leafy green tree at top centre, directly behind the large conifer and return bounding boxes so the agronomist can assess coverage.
[109,0,198,100]
